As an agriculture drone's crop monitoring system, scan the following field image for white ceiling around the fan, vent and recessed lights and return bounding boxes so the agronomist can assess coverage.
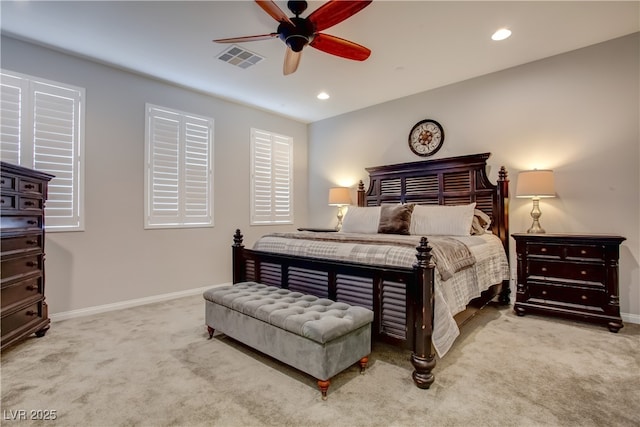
[0,0,640,122]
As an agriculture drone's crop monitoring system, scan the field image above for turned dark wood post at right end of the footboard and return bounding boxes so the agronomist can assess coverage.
[411,237,436,389]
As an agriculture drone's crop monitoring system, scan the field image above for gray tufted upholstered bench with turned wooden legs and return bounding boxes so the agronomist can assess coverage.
[204,282,373,399]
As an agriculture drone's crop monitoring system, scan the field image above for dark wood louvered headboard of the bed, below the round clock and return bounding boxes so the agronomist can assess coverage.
[358,153,509,254]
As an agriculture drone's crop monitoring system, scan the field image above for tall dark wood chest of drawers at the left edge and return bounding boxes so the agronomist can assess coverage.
[0,162,53,350]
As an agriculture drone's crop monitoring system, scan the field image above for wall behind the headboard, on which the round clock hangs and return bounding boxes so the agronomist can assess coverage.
[309,33,640,322]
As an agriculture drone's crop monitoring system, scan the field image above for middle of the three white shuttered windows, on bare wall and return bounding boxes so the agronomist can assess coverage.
[145,104,213,228]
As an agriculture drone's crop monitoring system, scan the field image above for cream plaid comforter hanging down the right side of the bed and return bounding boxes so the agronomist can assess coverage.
[253,233,509,357]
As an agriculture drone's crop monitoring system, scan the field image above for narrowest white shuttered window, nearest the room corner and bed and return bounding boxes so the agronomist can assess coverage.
[251,129,293,225]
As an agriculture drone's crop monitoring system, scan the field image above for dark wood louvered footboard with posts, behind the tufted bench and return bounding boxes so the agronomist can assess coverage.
[232,229,436,388]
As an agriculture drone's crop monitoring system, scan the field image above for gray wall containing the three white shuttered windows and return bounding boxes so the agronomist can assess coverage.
[2,37,308,314]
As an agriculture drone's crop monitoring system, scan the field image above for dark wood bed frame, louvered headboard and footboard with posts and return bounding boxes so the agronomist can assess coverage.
[233,153,510,388]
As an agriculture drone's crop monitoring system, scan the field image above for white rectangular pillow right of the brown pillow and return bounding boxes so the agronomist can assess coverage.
[409,202,476,236]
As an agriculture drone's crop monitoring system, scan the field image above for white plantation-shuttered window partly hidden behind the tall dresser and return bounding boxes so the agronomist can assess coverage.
[0,70,85,231]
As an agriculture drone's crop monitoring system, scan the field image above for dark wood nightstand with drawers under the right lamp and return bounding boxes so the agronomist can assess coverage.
[511,233,625,332]
